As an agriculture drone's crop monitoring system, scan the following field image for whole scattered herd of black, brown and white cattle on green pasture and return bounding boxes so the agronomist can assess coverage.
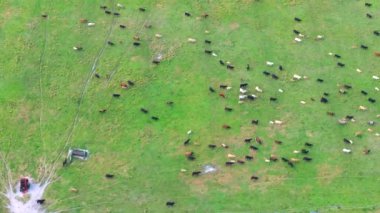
[31,0,380,207]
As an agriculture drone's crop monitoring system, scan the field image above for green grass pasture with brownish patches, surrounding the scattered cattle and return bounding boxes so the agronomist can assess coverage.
[0,0,380,212]
